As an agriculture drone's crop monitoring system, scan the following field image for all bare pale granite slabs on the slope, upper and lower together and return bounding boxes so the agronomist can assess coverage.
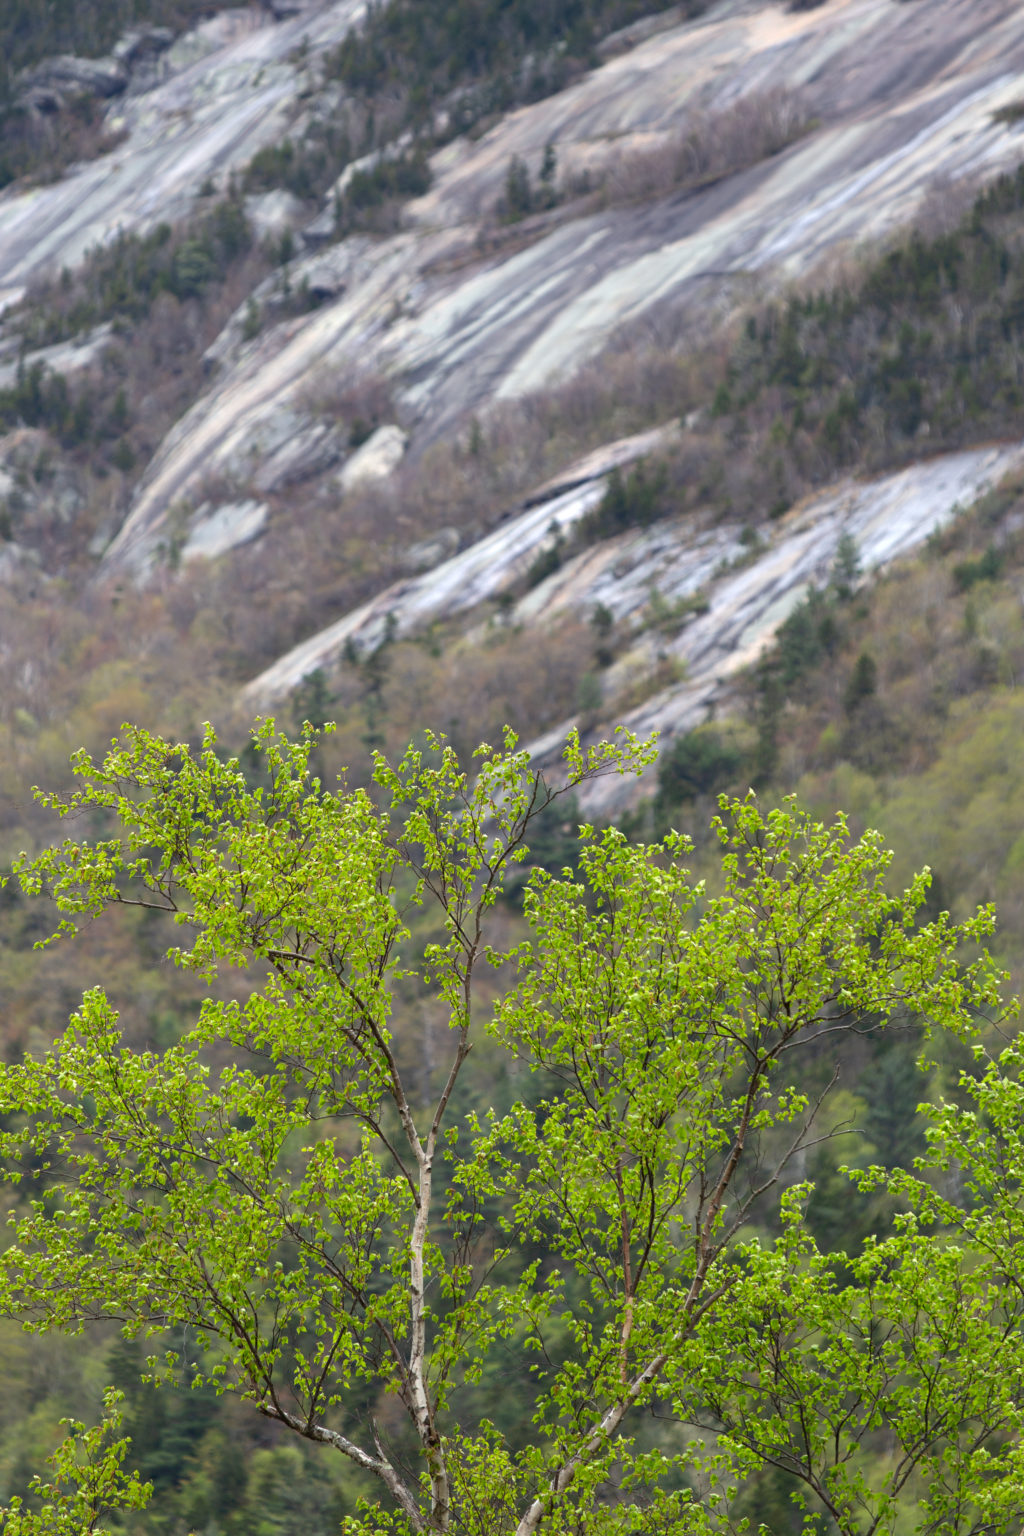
[0,0,1024,792]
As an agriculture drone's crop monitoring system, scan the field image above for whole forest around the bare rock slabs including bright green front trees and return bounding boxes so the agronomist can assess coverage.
[0,0,1024,1536]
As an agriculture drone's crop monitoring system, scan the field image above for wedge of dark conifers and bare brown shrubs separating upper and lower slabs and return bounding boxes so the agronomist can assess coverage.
[564,167,1024,559]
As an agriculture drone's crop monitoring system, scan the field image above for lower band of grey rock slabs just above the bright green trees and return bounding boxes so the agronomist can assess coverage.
[241,444,1024,752]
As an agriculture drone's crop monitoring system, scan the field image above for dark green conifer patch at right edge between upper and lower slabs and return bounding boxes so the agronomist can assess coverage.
[718,169,1024,467]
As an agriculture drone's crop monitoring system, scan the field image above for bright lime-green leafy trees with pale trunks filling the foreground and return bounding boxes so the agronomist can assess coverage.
[0,723,1024,1536]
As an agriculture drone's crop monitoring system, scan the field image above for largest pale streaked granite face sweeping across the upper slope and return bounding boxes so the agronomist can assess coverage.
[84,0,1024,573]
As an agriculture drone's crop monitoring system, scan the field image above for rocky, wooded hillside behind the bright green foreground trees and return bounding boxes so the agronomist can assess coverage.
[0,0,1024,1536]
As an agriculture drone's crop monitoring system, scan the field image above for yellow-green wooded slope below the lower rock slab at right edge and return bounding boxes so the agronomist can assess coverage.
[647,481,1024,964]
